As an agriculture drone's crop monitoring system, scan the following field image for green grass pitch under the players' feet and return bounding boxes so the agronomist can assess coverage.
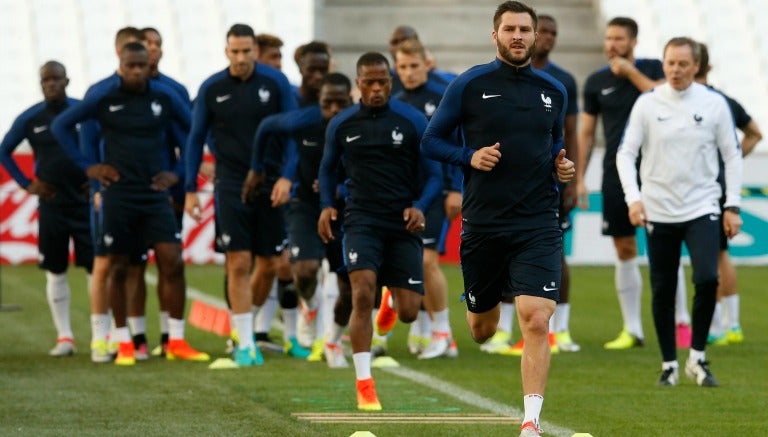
[0,266,768,437]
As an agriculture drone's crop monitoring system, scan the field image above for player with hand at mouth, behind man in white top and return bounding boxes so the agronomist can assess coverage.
[575,17,685,349]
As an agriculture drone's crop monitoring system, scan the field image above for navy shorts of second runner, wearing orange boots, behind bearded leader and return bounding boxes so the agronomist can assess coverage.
[344,225,424,294]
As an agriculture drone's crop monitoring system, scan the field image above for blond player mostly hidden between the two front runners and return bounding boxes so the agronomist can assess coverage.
[395,39,462,359]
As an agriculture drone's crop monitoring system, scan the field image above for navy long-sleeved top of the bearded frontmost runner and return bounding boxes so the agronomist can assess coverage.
[421,59,568,232]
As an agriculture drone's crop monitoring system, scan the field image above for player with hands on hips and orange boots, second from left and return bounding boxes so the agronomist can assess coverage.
[51,42,209,365]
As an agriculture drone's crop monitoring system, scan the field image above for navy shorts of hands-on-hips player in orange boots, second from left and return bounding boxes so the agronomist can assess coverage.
[101,190,181,257]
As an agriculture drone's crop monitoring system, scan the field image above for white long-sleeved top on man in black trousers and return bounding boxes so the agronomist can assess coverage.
[616,82,742,223]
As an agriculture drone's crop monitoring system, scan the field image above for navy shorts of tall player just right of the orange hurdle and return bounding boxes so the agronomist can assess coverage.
[216,186,286,256]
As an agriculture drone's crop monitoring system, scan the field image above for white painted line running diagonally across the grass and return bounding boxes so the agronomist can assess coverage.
[145,273,575,437]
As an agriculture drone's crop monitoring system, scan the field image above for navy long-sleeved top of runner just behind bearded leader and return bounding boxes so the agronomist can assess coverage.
[318,99,442,230]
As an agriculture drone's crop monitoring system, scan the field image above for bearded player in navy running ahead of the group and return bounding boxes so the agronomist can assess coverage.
[422,1,575,436]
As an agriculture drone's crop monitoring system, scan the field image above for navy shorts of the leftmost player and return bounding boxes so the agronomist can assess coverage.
[37,201,93,274]
